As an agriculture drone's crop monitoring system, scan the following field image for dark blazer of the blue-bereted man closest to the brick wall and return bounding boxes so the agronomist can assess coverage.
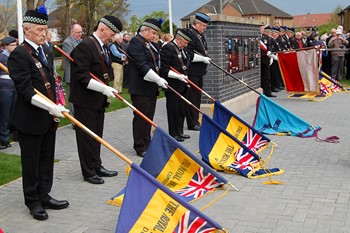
[187,27,208,77]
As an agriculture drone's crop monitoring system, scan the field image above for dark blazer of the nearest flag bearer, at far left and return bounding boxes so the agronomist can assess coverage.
[7,41,55,135]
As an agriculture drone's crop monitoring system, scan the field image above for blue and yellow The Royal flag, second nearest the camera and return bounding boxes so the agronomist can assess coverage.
[108,127,228,206]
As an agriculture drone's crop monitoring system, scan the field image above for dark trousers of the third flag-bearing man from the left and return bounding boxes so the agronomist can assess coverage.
[131,95,157,154]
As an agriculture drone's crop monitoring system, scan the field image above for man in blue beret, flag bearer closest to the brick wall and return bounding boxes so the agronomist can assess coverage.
[186,12,211,131]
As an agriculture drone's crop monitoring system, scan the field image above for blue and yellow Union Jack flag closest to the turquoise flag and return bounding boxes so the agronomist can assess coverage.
[213,101,271,153]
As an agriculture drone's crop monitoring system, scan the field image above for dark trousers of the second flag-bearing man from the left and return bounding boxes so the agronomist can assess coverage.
[74,105,105,177]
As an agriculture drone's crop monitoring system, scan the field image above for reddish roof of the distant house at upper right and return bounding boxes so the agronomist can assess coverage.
[293,13,333,27]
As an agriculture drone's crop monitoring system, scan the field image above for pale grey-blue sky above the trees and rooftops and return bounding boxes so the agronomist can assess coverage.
[127,0,350,25]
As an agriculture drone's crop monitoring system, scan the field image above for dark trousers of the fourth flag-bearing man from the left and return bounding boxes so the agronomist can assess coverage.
[165,92,186,137]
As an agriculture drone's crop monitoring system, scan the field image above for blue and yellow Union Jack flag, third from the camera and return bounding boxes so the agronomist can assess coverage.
[199,114,284,178]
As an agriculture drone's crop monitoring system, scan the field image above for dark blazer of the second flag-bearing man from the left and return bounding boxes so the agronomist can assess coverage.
[69,37,111,110]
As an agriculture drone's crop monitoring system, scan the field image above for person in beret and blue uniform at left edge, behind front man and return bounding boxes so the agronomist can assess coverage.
[0,36,17,150]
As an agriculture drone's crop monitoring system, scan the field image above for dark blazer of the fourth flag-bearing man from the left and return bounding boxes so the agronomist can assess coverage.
[160,41,186,94]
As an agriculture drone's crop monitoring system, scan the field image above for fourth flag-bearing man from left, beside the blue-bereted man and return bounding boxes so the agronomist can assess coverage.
[160,29,191,142]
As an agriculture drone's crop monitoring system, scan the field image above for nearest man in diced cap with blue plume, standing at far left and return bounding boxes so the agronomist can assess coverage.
[7,7,69,220]
